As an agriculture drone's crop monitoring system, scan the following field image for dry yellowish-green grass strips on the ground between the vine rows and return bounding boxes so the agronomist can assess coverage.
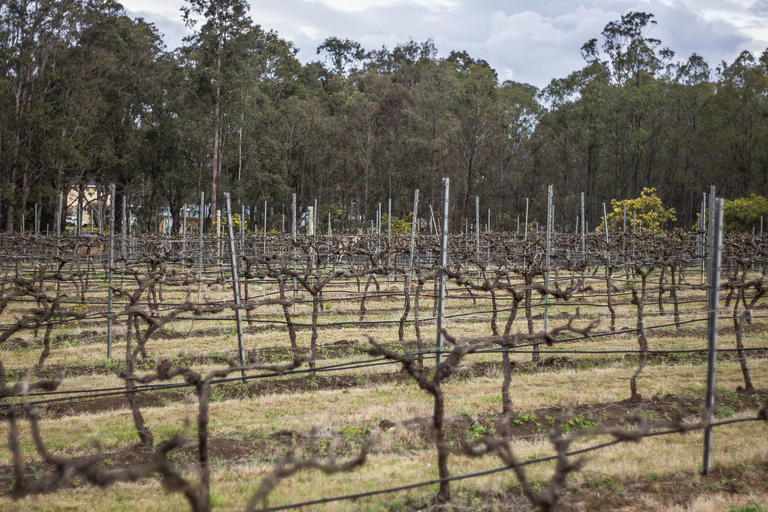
[0,270,768,512]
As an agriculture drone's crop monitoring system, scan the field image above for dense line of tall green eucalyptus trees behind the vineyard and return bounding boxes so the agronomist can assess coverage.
[0,0,768,232]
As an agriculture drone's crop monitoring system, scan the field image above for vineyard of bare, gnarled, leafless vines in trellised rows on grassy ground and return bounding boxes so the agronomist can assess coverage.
[0,226,768,511]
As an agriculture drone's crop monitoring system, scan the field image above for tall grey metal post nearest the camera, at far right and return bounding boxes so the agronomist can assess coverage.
[703,194,723,475]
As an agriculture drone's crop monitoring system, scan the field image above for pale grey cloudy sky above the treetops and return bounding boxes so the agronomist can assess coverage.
[123,0,768,87]
